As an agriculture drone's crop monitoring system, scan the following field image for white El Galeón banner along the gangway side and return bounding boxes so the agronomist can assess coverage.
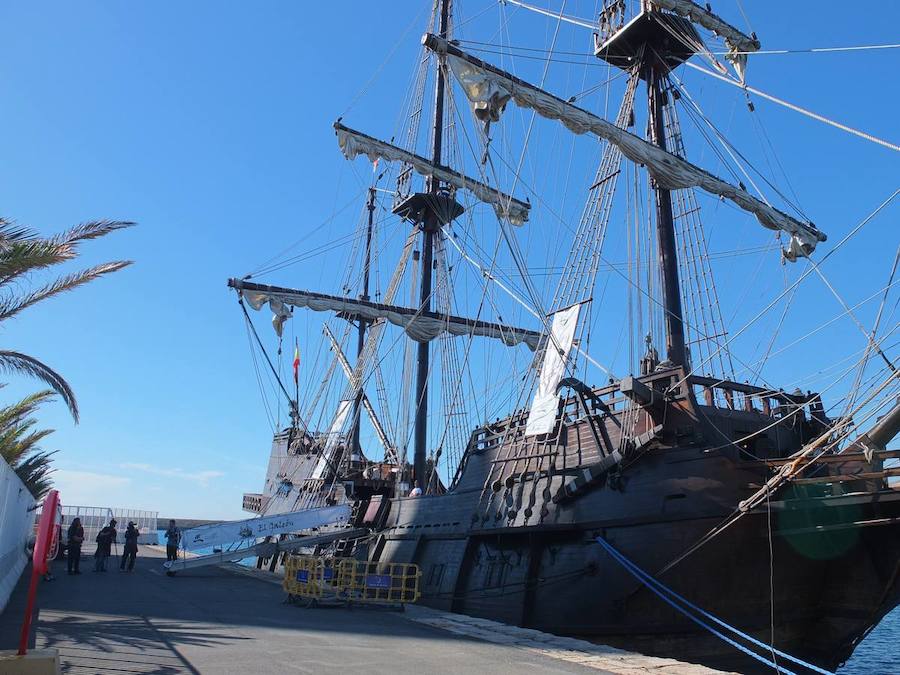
[181,504,350,550]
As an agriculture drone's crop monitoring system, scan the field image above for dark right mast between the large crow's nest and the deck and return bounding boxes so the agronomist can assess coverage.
[644,59,687,366]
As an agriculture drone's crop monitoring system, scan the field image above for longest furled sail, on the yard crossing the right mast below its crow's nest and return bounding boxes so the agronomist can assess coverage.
[423,34,826,261]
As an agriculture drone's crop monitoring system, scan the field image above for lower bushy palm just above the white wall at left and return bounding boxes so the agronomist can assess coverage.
[0,391,56,499]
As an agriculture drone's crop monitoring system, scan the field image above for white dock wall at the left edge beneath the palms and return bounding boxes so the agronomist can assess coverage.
[0,458,34,612]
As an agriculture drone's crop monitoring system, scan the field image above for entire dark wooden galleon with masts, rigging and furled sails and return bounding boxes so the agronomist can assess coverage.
[228,0,900,672]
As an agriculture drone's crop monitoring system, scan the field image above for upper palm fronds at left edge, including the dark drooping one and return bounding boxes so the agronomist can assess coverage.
[0,218,134,422]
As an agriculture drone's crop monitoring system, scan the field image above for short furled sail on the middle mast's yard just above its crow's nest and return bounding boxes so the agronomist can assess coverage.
[334,123,531,225]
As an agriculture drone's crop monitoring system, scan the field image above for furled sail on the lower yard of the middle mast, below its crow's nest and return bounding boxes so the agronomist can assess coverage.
[232,280,541,351]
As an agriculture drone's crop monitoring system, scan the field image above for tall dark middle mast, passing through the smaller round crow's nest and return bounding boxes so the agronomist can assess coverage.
[413,0,451,490]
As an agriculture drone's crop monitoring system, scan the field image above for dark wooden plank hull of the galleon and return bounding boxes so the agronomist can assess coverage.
[360,370,900,672]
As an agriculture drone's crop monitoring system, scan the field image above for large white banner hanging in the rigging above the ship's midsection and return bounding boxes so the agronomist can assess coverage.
[525,304,581,436]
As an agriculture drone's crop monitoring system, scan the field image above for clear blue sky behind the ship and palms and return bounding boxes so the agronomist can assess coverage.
[0,0,900,517]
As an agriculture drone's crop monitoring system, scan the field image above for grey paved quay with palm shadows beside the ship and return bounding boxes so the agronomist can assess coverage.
[0,547,714,675]
